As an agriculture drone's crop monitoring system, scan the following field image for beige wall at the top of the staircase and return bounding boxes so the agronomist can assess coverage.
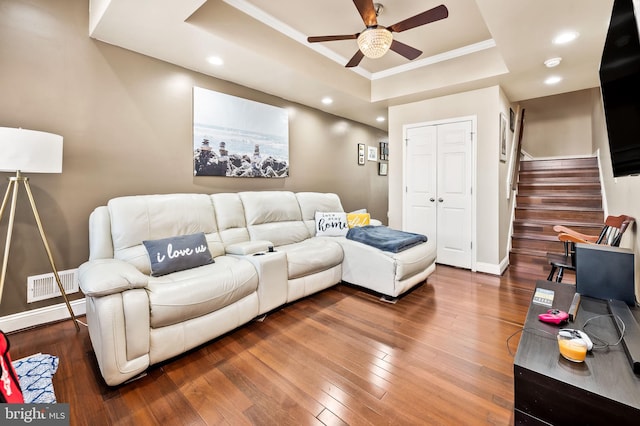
[520,89,593,158]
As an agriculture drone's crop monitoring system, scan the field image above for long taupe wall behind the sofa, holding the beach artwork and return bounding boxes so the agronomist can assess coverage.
[0,0,388,315]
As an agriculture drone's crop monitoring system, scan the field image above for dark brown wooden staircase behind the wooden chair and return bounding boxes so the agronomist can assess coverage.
[509,157,604,282]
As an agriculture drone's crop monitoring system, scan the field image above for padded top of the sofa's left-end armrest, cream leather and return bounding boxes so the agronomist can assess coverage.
[78,259,149,297]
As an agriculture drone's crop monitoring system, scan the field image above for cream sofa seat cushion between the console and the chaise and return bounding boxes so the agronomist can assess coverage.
[277,238,344,280]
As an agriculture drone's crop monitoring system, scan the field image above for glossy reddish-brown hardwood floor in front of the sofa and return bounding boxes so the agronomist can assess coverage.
[9,266,546,425]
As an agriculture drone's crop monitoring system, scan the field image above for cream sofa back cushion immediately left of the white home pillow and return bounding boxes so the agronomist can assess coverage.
[239,191,311,246]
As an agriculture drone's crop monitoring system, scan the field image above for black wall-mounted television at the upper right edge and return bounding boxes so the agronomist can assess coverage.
[600,0,640,177]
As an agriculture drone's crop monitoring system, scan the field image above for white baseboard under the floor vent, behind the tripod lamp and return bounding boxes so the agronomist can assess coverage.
[0,298,87,333]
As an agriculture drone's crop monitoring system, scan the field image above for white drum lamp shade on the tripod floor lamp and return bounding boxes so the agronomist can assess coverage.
[0,127,62,173]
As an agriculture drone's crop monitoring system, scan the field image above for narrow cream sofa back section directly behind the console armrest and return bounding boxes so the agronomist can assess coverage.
[211,193,250,246]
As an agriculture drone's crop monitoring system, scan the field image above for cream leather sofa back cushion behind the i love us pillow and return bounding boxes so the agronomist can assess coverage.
[107,194,224,274]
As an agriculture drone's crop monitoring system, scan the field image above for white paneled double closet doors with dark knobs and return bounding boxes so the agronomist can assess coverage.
[403,119,473,269]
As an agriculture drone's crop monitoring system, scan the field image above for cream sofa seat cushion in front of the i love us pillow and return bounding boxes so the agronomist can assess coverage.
[147,256,258,328]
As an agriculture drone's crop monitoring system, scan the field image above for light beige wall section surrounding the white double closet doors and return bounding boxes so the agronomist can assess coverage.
[389,86,510,273]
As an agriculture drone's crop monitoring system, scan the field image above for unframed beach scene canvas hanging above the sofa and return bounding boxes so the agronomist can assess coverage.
[193,87,289,178]
